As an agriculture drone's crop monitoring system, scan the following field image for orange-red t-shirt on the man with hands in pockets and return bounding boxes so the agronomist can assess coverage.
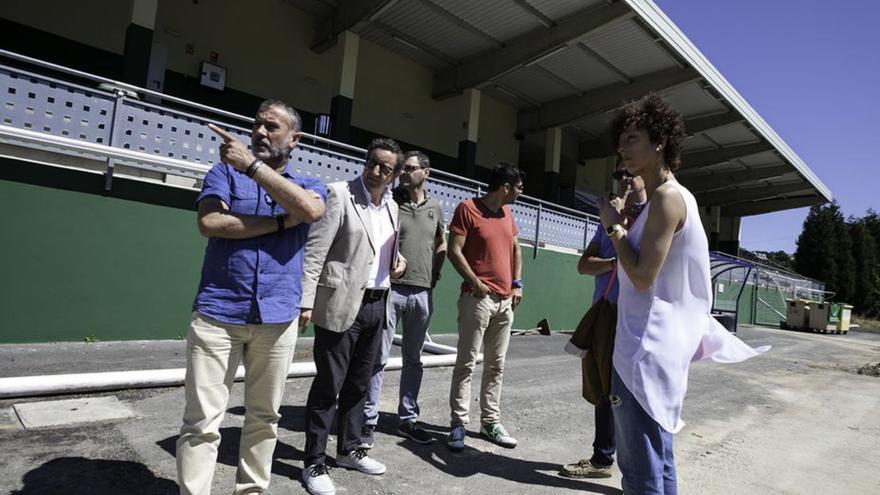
[449,199,517,298]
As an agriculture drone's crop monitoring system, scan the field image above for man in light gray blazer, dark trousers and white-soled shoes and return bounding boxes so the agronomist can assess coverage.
[300,138,406,495]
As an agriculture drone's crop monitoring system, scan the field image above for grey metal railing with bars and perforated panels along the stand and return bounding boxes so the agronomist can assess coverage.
[0,50,598,254]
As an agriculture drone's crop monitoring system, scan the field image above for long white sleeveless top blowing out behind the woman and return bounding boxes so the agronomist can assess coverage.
[614,180,769,433]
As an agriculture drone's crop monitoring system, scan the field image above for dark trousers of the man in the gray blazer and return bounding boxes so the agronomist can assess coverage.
[305,296,387,466]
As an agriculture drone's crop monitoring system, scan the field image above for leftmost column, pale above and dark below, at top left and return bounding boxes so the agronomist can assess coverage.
[122,0,159,86]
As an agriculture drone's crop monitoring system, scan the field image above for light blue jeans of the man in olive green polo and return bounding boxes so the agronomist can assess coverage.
[364,285,434,426]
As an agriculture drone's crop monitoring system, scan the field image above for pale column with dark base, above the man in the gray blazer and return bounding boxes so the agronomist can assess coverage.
[330,31,361,143]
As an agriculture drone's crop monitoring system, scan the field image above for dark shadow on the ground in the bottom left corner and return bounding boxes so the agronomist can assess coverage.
[10,457,178,495]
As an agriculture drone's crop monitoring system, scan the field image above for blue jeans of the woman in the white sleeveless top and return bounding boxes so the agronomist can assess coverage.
[611,371,678,495]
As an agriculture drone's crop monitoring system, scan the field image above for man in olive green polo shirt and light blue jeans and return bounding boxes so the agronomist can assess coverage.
[361,151,446,448]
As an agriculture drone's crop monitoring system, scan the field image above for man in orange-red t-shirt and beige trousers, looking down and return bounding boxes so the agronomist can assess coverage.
[446,162,525,451]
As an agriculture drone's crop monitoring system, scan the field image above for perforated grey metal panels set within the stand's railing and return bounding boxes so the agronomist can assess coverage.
[0,58,596,249]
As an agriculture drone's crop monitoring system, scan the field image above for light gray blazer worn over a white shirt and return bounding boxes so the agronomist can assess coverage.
[300,177,400,332]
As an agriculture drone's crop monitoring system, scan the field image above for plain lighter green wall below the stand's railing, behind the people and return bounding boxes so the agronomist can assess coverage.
[0,176,593,343]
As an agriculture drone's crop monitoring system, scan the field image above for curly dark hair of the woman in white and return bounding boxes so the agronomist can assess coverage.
[609,93,685,172]
